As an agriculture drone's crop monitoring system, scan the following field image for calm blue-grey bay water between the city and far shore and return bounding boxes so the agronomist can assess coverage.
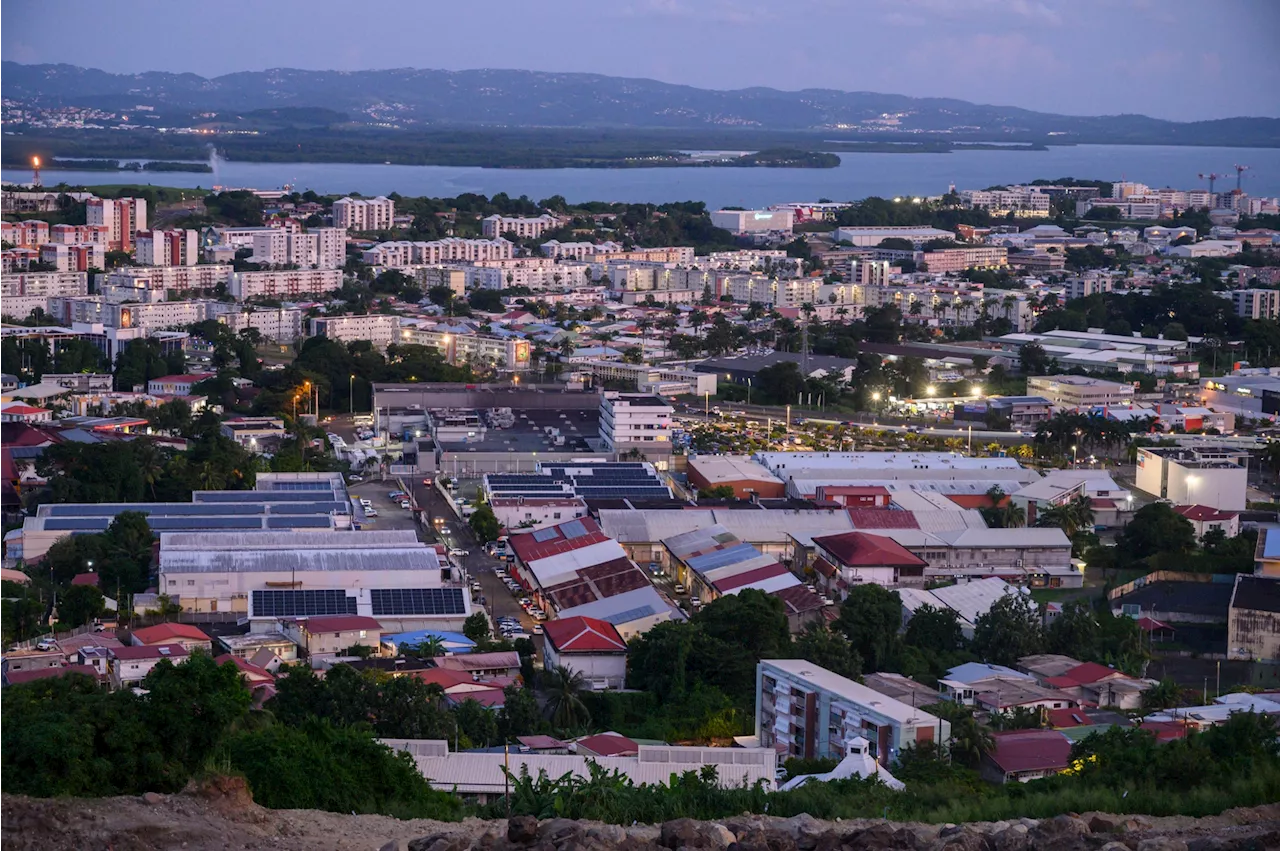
[10,145,1280,209]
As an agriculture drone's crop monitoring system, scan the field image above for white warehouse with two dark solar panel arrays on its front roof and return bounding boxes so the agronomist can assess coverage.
[159,530,471,632]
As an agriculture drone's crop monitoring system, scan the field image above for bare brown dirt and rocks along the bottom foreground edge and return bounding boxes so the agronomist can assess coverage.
[0,779,1280,851]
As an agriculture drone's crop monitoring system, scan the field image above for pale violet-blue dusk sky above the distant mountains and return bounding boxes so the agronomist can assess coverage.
[0,0,1280,120]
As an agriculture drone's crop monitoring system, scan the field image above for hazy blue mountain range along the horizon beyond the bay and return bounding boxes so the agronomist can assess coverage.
[0,61,1280,146]
